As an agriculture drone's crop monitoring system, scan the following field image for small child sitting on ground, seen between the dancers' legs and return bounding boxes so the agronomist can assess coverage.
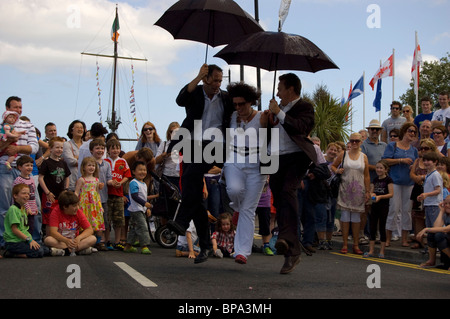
[211,213,236,258]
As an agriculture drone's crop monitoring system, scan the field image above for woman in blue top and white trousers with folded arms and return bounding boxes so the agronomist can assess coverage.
[382,123,419,247]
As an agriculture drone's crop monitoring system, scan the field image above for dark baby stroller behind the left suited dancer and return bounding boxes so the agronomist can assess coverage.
[149,172,181,248]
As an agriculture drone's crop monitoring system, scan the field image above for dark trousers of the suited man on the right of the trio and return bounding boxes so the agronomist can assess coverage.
[269,152,311,257]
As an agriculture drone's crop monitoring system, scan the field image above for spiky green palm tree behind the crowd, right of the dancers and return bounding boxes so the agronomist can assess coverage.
[303,84,352,151]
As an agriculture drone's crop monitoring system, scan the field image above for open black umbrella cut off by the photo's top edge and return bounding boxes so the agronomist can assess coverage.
[155,0,263,62]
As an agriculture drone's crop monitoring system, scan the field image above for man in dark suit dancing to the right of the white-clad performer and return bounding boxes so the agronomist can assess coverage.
[266,73,317,274]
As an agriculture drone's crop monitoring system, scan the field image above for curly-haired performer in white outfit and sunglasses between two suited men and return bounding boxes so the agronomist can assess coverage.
[223,82,267,264]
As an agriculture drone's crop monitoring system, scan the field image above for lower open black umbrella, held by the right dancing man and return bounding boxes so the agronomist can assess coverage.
[215,31,339,94]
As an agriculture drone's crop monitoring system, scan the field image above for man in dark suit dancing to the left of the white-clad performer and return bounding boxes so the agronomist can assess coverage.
[168,64,234,263]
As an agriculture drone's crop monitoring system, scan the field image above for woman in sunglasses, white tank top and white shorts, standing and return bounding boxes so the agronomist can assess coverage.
[331,133,370,255]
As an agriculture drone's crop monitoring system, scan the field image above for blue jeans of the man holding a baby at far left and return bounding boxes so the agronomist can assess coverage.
[0,164,20,247]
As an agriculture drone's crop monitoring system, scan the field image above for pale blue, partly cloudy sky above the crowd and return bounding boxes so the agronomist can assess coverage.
[0,0,450,151]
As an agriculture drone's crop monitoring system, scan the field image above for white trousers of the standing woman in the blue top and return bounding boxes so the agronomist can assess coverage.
[386,184,414,236]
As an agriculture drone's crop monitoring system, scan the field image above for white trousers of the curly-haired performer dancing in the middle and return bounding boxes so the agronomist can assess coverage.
[224,164,267,258]
